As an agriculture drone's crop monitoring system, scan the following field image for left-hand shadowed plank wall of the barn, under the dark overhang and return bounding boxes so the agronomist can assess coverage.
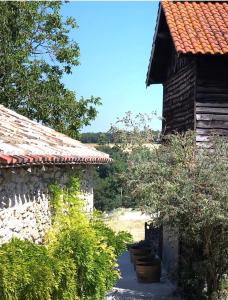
[162,62,196,134]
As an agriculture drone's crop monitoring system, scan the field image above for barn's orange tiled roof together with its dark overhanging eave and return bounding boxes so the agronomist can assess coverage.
[146,0,228,86]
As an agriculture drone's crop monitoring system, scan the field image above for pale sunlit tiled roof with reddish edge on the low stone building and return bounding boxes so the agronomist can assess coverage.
[0,105,111,167]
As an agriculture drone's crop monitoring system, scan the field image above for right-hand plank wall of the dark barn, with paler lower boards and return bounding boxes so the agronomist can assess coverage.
[196,56,228,142]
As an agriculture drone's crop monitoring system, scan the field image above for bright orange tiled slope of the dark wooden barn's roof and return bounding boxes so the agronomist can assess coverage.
[161,1,228,54]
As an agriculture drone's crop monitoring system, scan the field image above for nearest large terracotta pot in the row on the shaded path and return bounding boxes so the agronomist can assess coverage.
[136,260,161,283]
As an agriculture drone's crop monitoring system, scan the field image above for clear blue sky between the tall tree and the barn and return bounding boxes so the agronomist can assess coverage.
[62,1,162,132]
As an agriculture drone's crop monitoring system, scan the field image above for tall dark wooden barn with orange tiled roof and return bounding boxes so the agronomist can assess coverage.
[146,1,228,142]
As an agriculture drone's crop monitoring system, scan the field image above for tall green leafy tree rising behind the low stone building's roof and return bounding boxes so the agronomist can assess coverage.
[0,1,100,137]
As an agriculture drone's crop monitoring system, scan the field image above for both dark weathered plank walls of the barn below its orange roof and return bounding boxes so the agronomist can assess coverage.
[162,51,228,142]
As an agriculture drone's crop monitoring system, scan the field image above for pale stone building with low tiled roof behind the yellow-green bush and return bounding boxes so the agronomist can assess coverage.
[0,105,111,243]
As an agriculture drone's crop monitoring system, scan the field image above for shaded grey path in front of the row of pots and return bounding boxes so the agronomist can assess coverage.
[106,252,180,300]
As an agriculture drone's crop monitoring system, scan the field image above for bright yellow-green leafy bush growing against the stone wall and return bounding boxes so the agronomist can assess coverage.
[0,178,130,300]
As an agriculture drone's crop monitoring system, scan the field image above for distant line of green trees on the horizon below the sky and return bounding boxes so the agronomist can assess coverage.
[80,130,160,145]
